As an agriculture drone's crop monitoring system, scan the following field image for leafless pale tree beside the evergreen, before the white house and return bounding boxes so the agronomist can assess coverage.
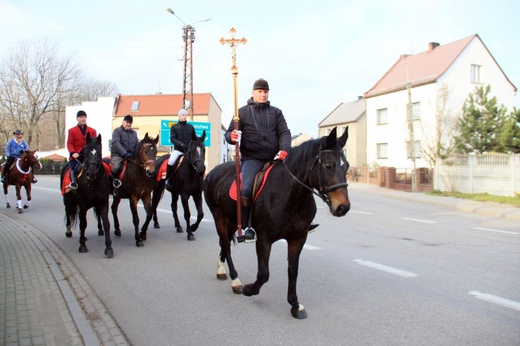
[419,85,457,167]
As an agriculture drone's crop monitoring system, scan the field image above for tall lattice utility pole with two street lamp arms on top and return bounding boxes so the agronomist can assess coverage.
[166,8,211,120]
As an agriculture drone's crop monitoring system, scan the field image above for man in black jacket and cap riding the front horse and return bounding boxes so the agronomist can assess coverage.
[225,78,291,243]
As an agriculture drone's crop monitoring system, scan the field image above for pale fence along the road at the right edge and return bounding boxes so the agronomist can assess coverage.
[433,153,520,197]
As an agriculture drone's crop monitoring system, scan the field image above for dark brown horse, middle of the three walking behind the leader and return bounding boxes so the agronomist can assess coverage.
[105,132,159,247]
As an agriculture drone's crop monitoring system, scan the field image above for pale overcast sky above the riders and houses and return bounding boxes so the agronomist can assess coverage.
[0,0,520,137]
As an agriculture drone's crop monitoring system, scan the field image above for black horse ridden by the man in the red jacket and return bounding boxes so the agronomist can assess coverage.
[60,133,114,258]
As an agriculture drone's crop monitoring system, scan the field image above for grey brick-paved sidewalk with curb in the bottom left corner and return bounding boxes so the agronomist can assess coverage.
[0,210,130,346]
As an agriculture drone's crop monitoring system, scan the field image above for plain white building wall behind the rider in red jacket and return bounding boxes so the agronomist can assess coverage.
[65,97,116,157]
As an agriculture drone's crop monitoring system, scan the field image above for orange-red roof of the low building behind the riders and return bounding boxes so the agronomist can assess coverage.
[115,93,211,117]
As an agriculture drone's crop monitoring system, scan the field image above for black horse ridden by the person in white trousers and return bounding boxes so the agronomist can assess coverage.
[141,130,206,240]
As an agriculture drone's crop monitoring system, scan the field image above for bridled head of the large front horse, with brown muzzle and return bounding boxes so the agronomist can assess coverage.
[310,127,350,216]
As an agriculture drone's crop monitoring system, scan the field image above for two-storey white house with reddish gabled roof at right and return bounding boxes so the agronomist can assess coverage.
[364,34,517,168]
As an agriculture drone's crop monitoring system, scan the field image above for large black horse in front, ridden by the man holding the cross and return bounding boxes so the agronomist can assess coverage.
[204,128,350,319]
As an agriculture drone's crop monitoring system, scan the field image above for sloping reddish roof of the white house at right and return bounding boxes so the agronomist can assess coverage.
[365,34,480,98]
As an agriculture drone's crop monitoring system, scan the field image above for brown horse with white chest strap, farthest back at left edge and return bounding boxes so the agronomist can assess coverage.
[2,150,42,214]
